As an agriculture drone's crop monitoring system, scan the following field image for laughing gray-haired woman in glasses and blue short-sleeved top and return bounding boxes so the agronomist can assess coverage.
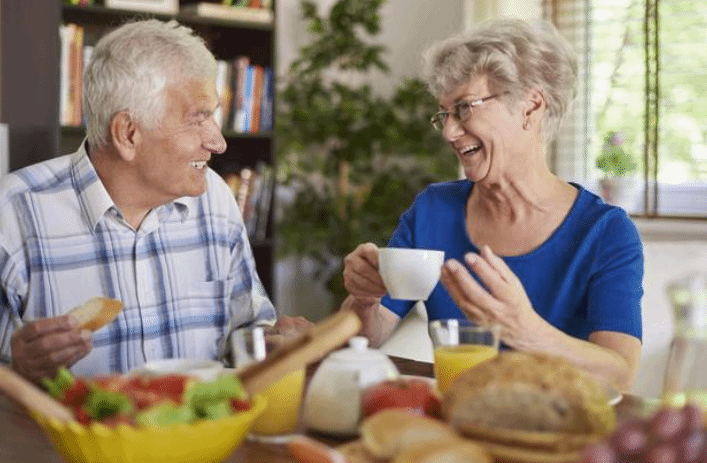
[344,20,643,391]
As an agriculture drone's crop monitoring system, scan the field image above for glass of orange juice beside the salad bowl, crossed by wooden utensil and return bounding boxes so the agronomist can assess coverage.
[230,326,305,443]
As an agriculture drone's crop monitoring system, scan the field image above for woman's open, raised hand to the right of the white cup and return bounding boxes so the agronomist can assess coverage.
[442,246,547,350]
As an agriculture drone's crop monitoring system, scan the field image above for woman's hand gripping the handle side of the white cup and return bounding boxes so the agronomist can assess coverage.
[344,243,386,309]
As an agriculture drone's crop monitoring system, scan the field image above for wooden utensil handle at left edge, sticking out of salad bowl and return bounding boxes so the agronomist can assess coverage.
[0,365,76,421]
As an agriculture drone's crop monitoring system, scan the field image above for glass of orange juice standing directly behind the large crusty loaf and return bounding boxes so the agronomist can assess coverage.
[428,319,500,393]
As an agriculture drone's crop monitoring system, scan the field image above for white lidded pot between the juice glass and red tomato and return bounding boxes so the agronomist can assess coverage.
[303,336,400,436]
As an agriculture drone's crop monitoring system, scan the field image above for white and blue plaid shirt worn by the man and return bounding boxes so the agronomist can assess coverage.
[0,145,276,375]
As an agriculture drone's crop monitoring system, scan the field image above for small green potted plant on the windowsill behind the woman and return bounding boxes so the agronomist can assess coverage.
[596,131,638,209]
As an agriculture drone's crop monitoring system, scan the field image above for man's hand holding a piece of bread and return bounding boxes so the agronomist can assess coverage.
[10,315,93,384]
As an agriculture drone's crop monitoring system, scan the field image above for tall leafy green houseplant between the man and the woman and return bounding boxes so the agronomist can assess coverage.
[276,0,457,306]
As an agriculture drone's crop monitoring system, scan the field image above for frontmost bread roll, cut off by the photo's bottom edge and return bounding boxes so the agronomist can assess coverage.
[392,438,493,463]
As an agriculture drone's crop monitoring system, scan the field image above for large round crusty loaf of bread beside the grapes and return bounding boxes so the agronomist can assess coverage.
[442,351,616,445]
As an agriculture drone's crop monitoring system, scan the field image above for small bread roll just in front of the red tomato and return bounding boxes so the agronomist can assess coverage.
[359,408,459,460]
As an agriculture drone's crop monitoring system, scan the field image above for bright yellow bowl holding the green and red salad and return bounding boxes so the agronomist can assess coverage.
[32,396,267,463]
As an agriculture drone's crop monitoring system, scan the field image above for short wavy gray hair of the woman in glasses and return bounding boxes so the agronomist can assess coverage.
[424,19,577,142]
